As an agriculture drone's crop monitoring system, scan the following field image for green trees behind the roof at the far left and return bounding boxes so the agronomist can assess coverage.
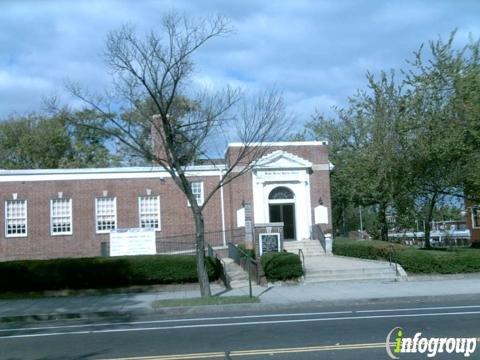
[0,112,118,169]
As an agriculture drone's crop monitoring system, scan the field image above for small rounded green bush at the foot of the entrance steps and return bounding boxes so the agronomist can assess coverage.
[261,252,303,281]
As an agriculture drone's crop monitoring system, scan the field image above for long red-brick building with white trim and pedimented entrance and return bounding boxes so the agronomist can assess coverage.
[0,141,331,260]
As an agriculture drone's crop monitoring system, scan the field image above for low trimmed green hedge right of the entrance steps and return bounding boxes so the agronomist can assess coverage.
[333,240,480,274]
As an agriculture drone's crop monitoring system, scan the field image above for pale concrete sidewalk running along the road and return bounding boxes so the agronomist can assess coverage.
[0,274,480,322]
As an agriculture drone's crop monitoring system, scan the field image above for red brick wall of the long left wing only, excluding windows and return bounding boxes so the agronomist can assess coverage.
[0,176,222,259]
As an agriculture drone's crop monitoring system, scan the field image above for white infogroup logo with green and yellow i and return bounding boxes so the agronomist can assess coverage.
[385,327,477,359]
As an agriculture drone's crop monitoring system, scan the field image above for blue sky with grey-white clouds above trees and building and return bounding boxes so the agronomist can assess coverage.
[0,0,480,126]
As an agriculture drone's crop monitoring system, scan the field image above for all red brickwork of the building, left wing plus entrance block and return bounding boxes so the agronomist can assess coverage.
[0,145,331,260]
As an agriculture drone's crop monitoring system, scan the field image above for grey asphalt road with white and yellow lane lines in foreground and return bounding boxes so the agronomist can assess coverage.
[0,298,480,360]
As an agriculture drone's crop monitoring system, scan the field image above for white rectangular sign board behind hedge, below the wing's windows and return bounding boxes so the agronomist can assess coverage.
[110,228,157,256]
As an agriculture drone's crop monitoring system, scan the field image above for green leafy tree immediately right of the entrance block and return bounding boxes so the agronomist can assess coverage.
[307,73,404,240]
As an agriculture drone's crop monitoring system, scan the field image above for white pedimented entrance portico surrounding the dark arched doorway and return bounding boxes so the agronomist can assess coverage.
[252,150,312,240]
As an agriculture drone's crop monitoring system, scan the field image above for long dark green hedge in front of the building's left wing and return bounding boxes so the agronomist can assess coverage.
[0,255,221,292]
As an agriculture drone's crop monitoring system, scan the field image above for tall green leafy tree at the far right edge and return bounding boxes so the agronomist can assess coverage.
[405,33,480,248]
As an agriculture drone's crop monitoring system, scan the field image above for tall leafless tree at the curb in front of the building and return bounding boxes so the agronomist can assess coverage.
[62,14,291,297]
